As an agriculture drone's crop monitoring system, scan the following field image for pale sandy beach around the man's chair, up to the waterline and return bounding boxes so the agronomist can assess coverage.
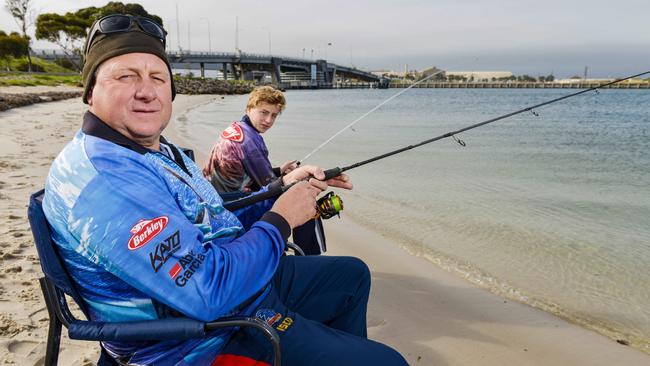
[0,88,650,365]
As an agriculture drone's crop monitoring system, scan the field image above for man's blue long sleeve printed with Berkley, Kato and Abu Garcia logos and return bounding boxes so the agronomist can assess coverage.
[44,136,289,321]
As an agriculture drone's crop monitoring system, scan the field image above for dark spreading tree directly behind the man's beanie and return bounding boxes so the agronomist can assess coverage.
[34,0,162,69]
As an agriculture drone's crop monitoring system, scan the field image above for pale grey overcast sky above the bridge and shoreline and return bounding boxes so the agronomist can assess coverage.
[0,0,650,78]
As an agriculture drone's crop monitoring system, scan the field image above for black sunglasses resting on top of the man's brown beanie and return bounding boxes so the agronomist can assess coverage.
[84,14,167,55]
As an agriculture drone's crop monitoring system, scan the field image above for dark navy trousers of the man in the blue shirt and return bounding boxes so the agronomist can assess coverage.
[215,256,407,366]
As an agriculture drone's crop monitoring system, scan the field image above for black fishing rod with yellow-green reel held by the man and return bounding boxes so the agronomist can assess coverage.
[224,71,650,213]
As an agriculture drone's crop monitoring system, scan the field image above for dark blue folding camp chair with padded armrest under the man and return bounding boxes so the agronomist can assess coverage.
[28,190,281,366]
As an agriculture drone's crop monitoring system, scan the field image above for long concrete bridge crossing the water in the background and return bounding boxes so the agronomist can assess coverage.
[33,51,388,89]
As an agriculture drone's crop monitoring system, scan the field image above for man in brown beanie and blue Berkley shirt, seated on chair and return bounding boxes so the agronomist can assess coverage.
[43,15,406,365]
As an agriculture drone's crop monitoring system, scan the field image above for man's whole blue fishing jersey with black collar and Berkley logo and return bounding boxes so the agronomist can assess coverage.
[43,112,290,365]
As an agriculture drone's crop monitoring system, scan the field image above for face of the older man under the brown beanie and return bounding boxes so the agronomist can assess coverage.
[88,53,172,149]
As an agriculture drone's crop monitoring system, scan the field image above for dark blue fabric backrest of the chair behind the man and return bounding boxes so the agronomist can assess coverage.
[27,189,88,315]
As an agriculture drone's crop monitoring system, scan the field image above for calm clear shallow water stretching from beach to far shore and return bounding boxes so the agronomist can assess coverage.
[179,89,650,352]
